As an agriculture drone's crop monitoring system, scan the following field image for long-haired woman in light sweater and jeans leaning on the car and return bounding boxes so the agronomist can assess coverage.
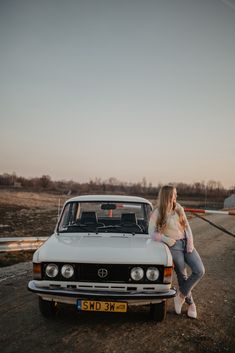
[149,185,205,319]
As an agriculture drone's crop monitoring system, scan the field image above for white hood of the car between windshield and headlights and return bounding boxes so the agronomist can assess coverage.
[33,233,172,266]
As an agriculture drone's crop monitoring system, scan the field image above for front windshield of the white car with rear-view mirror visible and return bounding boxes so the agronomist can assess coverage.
[57,201,151,234]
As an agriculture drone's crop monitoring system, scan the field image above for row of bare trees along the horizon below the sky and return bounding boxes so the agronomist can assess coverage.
[0,173,235,202]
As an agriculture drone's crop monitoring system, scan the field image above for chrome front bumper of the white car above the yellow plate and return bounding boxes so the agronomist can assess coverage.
[28,280,176,305]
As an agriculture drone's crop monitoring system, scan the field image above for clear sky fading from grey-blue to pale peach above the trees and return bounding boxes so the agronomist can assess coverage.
[0,0,235,187]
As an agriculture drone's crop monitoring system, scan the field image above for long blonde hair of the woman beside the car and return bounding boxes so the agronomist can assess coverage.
[156,185,186,232]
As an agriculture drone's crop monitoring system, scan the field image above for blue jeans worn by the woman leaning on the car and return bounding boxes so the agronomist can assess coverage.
[169,239,205,304]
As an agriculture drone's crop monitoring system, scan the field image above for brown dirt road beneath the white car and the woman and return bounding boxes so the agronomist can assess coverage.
[0,210,235,353]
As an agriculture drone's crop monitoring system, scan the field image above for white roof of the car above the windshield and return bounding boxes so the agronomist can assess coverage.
[66,195,152,205]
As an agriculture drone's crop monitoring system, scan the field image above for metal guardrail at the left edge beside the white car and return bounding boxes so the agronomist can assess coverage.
[0,237,48,252]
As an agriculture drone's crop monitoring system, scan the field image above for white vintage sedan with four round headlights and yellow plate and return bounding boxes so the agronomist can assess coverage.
[28,195,175,321]
